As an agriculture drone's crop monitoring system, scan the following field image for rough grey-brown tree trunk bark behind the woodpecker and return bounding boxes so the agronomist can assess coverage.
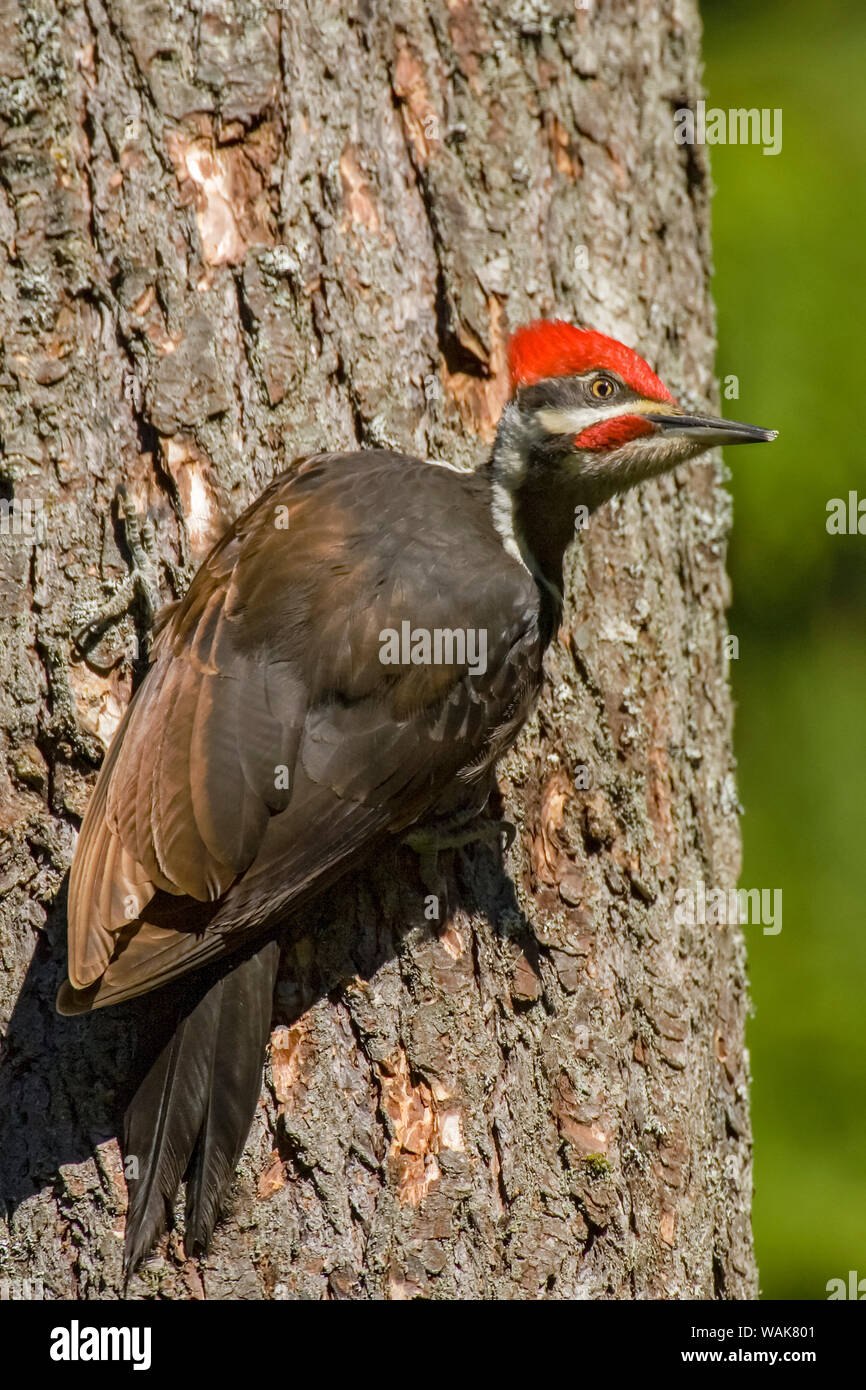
[0,0,755,1298]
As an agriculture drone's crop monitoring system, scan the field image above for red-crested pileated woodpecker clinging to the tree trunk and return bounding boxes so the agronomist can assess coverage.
[57,321,774,1269]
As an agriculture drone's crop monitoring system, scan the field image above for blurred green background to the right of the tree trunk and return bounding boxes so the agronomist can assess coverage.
[701,0,866,1298]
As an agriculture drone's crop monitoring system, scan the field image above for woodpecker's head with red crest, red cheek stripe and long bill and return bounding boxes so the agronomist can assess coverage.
[493,321,776,510]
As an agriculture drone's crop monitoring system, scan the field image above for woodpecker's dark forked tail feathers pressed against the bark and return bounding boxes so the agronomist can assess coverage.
[122,941,279,1275]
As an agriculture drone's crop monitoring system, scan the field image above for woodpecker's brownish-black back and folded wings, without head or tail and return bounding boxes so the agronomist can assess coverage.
[60,453,538,1012]
